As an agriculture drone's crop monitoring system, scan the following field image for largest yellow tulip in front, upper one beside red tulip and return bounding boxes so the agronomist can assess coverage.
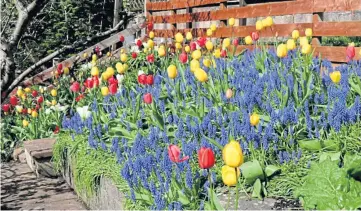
[222,140,244,168]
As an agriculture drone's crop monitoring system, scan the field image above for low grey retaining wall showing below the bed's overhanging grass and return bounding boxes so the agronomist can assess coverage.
[62,149,125,210]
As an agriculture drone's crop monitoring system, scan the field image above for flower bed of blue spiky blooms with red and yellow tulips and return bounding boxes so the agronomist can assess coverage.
[3,18,361,210]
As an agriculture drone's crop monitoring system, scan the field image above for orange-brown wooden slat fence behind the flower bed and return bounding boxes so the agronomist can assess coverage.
[146,0,361,62]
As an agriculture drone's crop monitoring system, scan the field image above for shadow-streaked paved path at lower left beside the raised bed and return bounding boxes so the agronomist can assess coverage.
[1,162,86,210]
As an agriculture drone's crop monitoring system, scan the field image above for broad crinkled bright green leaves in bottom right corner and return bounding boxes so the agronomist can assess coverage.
[295,155,361,210]
